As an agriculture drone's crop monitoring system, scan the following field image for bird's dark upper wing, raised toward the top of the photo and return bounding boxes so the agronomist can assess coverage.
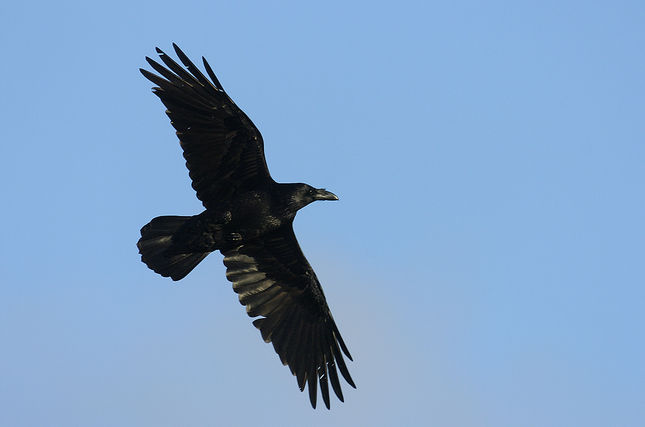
[140,43,271,209]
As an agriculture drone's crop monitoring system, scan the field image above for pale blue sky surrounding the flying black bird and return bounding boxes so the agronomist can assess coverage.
[0,0,645,427]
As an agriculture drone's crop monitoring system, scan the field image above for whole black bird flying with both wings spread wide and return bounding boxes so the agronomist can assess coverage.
[137,43,356,408]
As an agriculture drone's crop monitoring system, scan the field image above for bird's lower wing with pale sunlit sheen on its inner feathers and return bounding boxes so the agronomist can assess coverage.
[223,225,356,408]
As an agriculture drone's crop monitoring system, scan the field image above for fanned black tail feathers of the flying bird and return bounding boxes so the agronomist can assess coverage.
[137,216,210,280]
